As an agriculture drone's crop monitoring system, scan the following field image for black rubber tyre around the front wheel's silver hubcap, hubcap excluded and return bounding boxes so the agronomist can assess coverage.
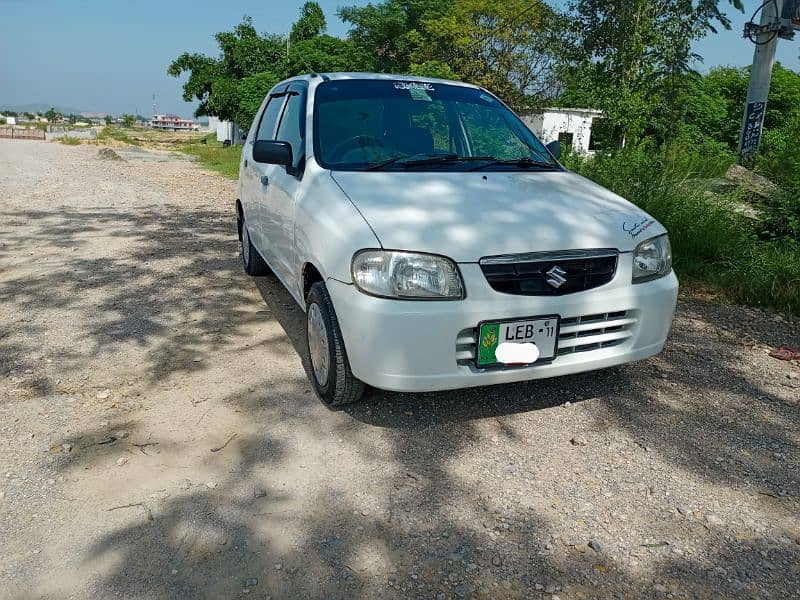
[306,281,365,406]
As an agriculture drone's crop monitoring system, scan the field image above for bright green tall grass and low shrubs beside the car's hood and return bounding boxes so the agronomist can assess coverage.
[569,142,800,314]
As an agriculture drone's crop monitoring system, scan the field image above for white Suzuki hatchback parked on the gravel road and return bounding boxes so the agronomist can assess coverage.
[236,73,678,404]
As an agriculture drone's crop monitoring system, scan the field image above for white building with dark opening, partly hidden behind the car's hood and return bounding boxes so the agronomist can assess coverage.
[521,108,603,155]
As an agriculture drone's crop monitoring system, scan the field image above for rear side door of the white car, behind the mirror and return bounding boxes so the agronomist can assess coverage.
[240,87,286,255]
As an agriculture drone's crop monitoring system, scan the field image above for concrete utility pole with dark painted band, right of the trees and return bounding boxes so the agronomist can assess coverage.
[737,0,800,165]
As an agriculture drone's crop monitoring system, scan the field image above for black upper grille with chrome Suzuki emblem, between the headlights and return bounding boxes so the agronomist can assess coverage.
[480,249,617,296]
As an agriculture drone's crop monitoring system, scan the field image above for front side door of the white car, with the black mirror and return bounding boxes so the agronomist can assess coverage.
[264,82,307,285]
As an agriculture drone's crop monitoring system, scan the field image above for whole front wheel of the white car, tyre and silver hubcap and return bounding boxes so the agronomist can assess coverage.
[306,281,364,406]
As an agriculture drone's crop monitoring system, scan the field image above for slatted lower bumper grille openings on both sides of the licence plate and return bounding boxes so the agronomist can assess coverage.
[456,310,637,368]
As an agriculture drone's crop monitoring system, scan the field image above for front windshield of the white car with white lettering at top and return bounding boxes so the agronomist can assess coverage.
[314,79,561,171]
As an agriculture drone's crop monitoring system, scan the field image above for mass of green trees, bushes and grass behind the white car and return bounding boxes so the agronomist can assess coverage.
[161,0,800,314]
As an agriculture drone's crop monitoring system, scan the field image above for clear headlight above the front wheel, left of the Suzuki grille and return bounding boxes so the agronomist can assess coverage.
[353,250,464,300]
